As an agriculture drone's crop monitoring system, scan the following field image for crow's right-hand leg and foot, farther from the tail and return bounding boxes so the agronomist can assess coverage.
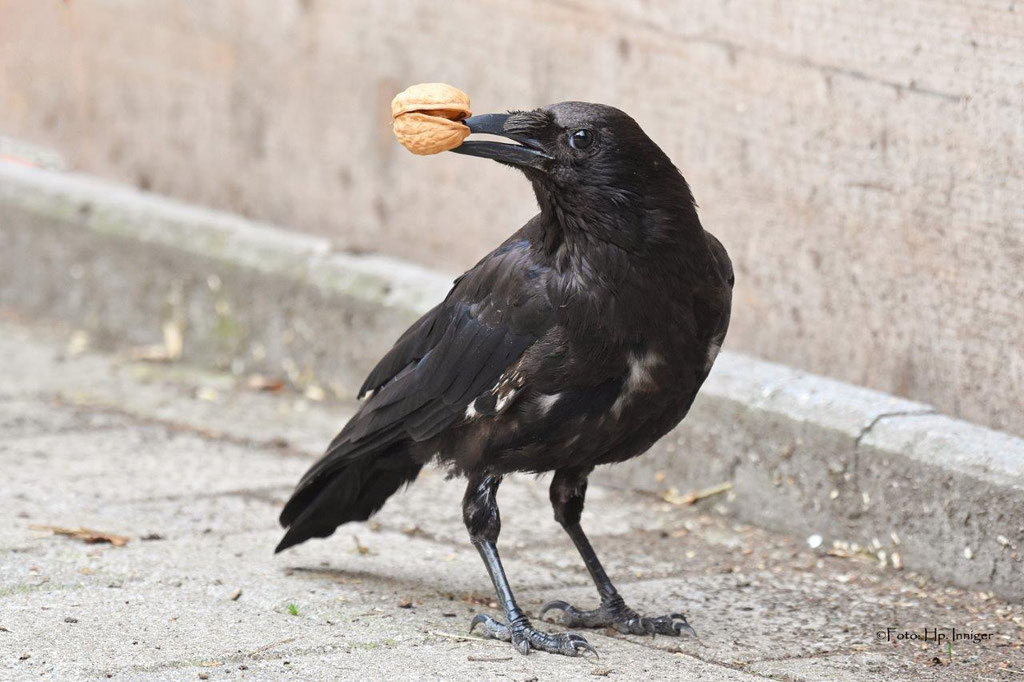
[541,469,696,636]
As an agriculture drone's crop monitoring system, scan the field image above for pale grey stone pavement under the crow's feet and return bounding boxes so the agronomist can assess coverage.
[0,314,1024,680]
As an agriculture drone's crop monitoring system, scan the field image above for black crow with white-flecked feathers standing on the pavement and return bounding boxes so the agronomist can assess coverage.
[276,101,733,655]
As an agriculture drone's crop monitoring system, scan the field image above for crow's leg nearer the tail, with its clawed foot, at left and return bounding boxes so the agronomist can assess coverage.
[462,476,596,656]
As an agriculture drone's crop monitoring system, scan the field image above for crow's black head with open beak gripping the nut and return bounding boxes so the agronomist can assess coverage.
[453,101,693,227]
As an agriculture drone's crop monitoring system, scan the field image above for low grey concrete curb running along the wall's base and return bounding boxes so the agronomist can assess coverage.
[0,163,1024,600]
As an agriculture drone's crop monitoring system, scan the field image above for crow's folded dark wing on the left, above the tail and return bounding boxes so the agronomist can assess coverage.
[299,236,551,488]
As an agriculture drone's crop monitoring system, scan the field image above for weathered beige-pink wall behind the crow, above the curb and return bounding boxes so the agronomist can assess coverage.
[0,0,1024,433]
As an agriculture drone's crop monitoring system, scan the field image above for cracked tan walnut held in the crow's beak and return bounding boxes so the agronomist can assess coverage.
[391,83,471,155]
